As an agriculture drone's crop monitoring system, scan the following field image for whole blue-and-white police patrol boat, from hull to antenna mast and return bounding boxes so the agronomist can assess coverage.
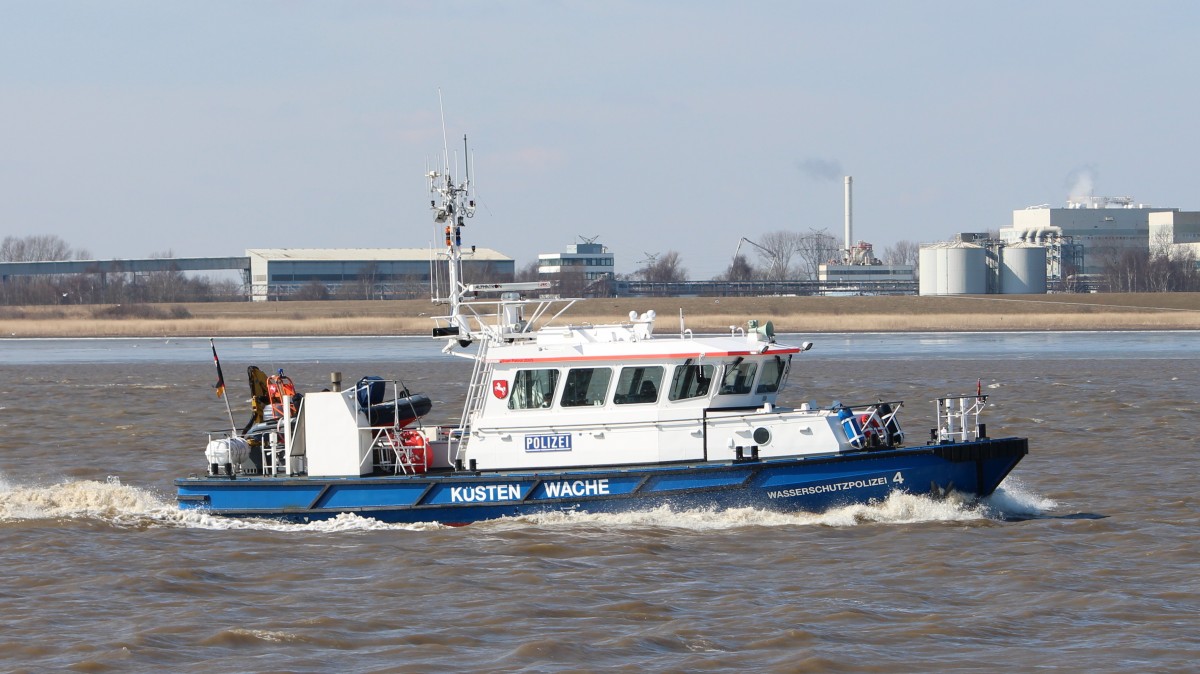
[175,131,1028,524]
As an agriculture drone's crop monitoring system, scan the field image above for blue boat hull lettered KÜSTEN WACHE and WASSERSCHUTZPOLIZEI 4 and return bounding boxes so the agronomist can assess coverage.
[175,438,1028,524]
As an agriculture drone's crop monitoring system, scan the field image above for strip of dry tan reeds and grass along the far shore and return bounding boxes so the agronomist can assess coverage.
[0,293,1200,338]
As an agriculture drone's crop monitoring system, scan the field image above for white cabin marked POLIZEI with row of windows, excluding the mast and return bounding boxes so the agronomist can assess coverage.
[456,312,830,470]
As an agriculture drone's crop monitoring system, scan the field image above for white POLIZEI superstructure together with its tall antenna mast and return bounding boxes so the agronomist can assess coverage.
[417,131,901,470]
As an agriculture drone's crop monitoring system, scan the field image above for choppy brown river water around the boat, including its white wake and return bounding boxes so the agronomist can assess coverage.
[0,333,1200,672]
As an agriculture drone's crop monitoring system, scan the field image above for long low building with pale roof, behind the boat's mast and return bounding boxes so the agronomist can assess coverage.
[246,248,515,301]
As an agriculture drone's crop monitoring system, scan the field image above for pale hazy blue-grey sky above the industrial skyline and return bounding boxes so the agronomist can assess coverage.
[0,0,1200,278]
